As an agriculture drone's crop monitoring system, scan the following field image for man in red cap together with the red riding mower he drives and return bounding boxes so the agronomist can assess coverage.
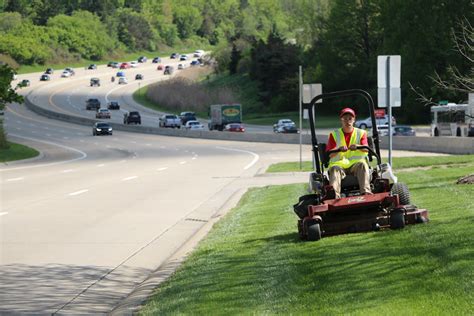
[294,90,428,241]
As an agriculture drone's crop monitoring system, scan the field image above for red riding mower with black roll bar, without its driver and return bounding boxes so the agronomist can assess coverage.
[293,89,428,241]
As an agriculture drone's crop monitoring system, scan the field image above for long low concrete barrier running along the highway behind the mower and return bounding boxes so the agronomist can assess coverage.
[25,97,474,154]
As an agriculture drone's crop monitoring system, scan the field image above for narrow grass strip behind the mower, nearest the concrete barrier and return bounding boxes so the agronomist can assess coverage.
[267,155,474,172]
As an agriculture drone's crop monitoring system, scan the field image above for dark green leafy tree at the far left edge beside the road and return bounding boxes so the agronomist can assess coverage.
[0,64,23,149]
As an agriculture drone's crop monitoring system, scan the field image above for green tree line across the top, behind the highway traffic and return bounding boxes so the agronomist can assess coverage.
[0,0,474,123]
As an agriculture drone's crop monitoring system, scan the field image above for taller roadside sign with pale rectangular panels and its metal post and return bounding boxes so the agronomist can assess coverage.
[377,55,401,165]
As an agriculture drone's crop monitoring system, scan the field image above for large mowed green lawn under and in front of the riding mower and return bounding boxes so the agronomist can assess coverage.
[141,157,474,315]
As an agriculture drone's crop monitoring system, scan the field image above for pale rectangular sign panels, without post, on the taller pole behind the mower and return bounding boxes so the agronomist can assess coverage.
[377,55,402,108]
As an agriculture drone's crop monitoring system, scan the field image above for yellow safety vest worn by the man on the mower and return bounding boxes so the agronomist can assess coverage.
[329,128,367,169]
